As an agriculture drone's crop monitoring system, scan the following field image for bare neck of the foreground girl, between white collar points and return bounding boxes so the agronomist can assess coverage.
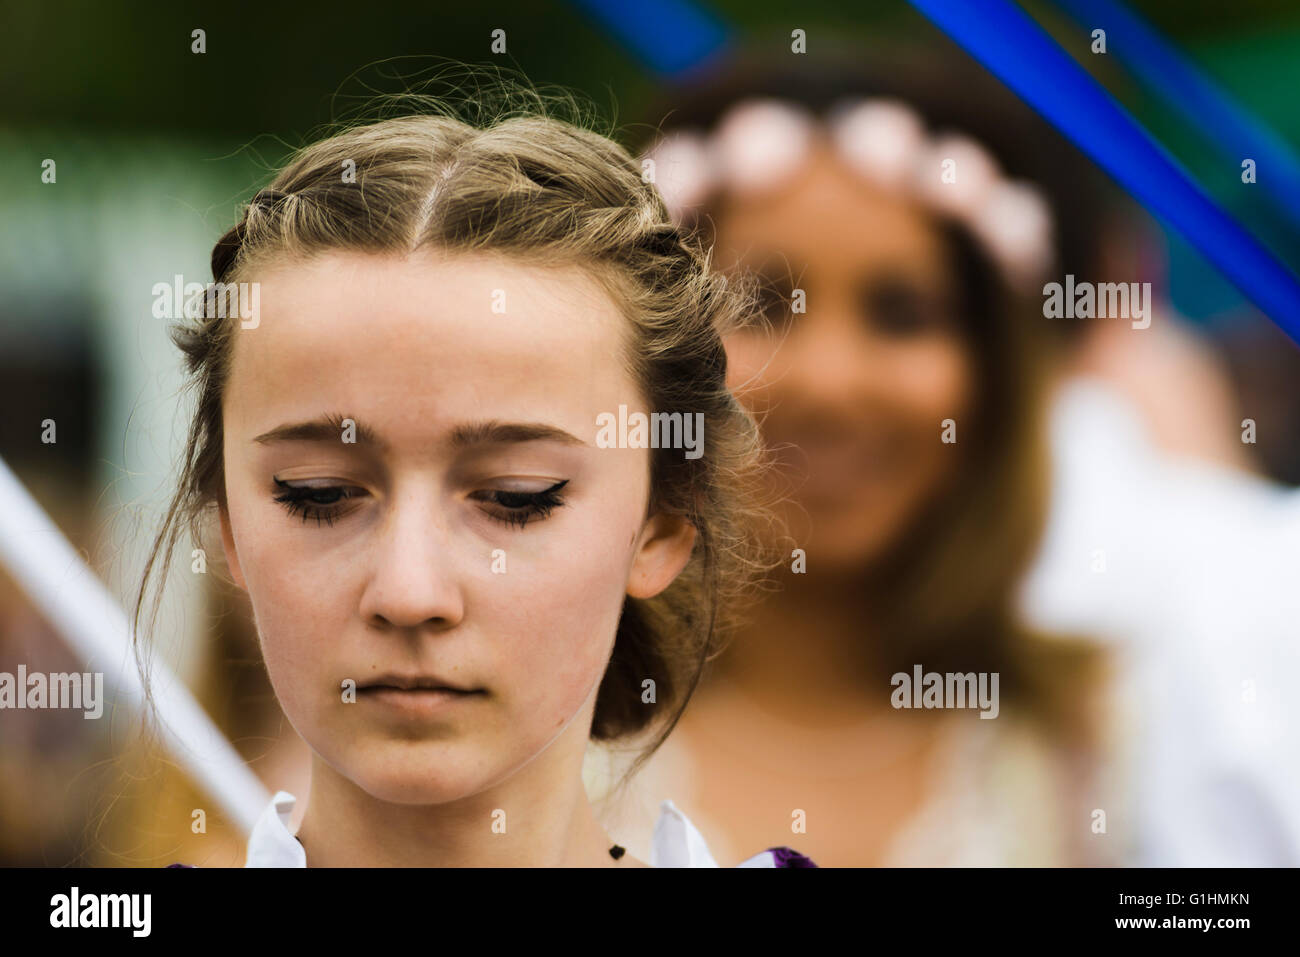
[296,738,645,867]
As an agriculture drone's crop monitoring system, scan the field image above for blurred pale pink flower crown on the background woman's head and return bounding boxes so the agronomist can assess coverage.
[642,99,1054,291]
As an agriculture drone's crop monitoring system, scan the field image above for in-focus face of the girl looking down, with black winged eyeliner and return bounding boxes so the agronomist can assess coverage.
[221,251,694,804]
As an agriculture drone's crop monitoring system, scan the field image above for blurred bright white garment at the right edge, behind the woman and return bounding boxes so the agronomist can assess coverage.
[1022,380,1300,866]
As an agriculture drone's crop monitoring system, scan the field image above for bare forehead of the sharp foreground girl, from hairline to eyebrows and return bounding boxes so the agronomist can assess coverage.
[225,254,636,447]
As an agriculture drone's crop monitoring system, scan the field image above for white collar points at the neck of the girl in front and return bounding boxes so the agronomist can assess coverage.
[244,791,775,867]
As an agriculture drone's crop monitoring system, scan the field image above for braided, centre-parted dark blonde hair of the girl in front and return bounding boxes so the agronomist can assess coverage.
[135,74,774,776]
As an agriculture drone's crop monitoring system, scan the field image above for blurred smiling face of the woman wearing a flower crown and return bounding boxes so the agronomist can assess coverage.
[714,140,975,568]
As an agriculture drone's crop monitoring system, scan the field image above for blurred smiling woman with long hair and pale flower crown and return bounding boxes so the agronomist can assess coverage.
[590,52,1130,866]
